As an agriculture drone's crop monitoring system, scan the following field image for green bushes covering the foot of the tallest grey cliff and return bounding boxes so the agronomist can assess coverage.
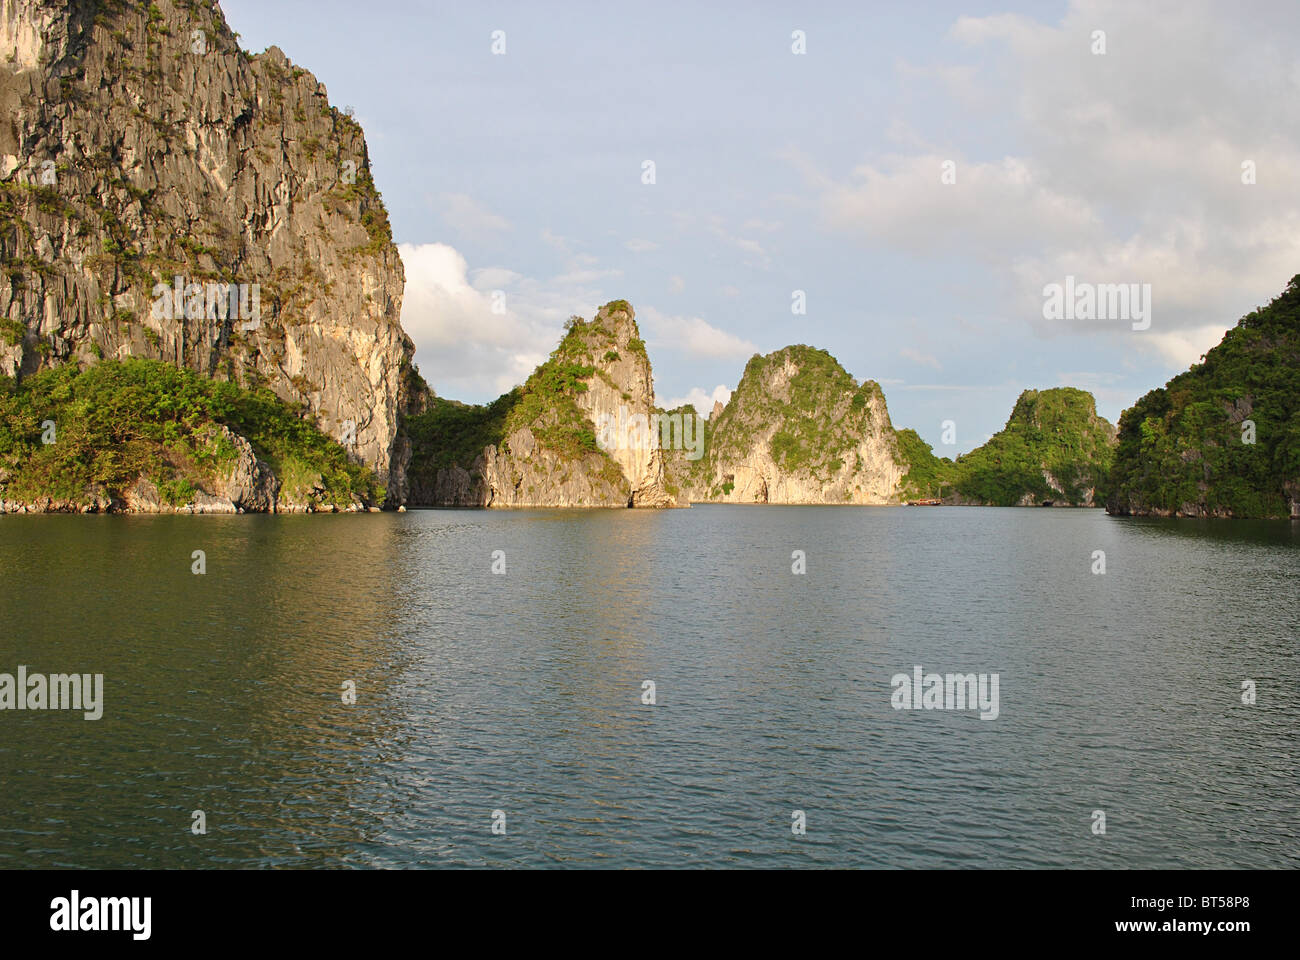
[0,358,384,506]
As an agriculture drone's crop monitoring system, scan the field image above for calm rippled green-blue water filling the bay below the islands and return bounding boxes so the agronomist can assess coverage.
[0,506,1300,868]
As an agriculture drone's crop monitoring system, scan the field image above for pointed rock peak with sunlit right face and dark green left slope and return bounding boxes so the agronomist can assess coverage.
[410,300,673,507]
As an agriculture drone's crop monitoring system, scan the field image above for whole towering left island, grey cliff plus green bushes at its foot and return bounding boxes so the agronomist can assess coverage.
[0,0,424,511]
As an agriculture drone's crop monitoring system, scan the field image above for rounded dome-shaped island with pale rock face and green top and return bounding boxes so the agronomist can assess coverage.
[673,346,909,503]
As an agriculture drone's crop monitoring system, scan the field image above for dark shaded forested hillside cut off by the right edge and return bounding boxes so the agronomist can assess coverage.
[1106,276,1300,518]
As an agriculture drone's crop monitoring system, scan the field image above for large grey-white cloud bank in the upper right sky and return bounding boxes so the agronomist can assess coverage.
[806,0,1300,356]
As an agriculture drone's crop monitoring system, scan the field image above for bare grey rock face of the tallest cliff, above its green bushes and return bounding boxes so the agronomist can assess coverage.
[0,0,420,502]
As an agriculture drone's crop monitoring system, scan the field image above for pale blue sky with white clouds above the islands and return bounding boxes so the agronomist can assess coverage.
[221,0,1300,455]
